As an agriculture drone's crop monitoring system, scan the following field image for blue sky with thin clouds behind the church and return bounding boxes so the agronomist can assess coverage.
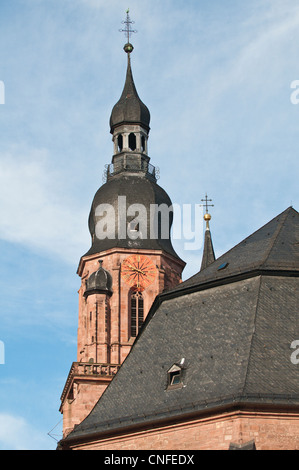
[0,0,299,449]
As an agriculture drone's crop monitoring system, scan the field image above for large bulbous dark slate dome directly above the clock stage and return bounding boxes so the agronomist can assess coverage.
[85,173,180,259]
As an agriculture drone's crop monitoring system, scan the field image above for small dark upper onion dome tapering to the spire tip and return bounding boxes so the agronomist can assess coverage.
[110,58,150,134]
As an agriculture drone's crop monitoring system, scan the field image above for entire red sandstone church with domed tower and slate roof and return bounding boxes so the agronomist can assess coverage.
[58,13,299,450]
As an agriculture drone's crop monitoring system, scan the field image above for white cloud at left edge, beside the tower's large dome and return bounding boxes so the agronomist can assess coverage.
[0,147,88,262]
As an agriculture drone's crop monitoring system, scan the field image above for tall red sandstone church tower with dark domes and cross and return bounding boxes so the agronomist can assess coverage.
[60,12,185,436]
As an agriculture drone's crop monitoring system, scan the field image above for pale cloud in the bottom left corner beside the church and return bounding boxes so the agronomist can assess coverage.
[0,413,50,450]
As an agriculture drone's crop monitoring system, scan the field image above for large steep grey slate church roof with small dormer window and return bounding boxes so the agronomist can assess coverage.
[64,208,299,444]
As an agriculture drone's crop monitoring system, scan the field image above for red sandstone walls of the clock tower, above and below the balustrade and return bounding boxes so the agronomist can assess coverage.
[60,249,185,436]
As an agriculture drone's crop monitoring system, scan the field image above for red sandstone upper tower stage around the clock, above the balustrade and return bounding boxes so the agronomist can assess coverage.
[77,249,184,364]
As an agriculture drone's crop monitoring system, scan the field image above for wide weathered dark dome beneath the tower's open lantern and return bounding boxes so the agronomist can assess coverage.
[86,173,179,258]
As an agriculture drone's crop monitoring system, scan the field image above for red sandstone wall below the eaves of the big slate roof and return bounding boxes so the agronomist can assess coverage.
[69,411,299,450]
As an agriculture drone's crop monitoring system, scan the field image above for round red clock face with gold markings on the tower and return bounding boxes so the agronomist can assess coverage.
[121,255,157,291]
